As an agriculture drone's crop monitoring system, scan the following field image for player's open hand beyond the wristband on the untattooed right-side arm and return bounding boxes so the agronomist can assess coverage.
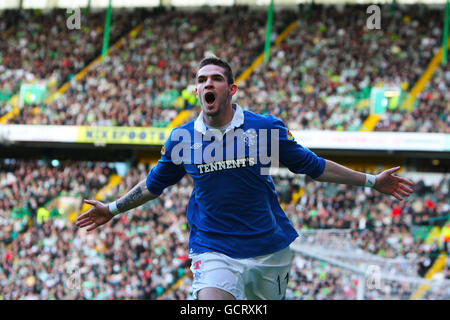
[373,167,414,201]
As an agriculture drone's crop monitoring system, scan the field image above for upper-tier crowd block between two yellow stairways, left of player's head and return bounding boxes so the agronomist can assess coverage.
[5,7,295,127]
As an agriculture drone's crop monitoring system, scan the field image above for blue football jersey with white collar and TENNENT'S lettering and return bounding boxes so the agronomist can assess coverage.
[147,104,325,258]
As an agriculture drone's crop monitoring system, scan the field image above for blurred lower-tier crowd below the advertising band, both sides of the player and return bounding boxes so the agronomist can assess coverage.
[0,160,449,299]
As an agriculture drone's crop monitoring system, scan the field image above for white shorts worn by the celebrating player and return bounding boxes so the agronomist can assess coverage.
[189,247,294,300]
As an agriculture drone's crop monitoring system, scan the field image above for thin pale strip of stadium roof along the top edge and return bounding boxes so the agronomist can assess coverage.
[0,0,446,9]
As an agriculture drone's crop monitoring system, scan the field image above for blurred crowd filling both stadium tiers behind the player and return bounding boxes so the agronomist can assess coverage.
[0,6,450,299]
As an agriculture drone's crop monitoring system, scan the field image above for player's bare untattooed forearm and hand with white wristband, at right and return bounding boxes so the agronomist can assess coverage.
[315,160,414,200]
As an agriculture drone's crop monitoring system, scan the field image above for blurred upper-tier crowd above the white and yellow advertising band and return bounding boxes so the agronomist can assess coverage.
[1,6,449,132]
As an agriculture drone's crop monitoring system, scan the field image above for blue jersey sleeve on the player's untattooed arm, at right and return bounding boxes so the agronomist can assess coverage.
[269,116,325,179]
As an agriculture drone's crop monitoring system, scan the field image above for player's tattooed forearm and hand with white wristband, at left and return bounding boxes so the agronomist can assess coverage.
[76,180,158,231]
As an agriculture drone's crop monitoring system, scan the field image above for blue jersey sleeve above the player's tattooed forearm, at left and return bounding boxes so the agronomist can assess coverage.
[147,131,186,196]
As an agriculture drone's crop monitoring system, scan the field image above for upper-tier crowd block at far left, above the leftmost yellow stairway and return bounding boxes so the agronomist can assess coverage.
[0,9,145,116]
